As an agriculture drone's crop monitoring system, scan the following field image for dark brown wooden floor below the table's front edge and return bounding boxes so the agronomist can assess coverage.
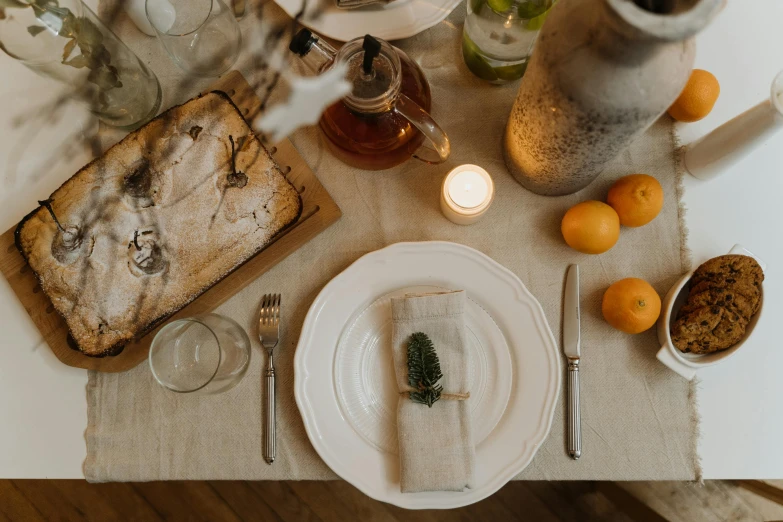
[0,480,783,522]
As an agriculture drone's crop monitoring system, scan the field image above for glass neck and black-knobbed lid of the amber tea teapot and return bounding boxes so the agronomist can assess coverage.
[337,35,402,113]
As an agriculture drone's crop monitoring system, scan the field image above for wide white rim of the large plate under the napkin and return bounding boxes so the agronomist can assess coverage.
[294,241,561,509]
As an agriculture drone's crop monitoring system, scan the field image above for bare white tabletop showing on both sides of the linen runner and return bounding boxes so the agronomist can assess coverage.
[0,0,783,478]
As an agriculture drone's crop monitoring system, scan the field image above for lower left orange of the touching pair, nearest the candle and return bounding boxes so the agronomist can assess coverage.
[560,201,620,254]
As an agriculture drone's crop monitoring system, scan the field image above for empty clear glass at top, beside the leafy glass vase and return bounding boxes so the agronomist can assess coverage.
[145,0,242,76]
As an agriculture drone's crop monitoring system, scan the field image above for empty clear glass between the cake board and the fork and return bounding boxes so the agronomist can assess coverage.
[149,314,250,393]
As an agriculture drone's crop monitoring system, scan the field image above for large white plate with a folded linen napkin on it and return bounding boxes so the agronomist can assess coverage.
[294,242,561,508]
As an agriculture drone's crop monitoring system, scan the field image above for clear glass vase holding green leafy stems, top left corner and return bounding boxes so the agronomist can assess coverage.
[0,0,161,130]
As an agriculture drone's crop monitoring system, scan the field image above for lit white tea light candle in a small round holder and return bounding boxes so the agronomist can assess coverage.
[440,165,495,225]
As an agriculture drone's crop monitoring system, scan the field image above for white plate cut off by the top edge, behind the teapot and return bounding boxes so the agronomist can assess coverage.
[275,0,460,42]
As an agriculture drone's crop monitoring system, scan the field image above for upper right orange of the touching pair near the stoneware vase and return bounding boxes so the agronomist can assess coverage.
[606,174,663,227]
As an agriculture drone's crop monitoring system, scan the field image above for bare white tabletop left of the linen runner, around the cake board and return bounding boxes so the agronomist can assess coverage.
[0,57,95,478]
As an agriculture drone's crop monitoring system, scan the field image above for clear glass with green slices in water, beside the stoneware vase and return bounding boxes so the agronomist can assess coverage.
[462,0,556,84]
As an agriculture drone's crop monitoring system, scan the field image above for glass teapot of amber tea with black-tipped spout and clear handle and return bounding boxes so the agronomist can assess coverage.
[289,29,451,170]
